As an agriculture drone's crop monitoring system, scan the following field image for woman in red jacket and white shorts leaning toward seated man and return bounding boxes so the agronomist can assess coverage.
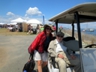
[28,25,53,72]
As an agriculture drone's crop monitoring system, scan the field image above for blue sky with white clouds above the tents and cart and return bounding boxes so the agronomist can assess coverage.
[0,0,96,28]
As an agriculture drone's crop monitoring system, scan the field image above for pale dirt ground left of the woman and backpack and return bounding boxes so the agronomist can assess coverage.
[0,35,36,72]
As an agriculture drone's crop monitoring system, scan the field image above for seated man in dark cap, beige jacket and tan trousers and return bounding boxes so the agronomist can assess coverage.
[48,32,81,72]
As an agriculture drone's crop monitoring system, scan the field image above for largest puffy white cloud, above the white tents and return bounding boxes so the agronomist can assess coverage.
[25,7,42,16]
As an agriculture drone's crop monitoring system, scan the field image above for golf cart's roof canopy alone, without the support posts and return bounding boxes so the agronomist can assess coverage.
[49,2,96,24]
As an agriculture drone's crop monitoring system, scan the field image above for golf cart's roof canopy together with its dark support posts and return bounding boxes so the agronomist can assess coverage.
[49,2,96,48]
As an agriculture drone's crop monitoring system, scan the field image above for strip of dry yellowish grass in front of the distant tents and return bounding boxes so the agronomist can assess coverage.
[0,28,33,35]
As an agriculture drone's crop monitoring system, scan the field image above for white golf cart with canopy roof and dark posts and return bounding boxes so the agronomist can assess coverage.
[48,2,96,72]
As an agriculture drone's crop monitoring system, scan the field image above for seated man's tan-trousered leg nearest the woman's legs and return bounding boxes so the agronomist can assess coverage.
[55,58,67,72]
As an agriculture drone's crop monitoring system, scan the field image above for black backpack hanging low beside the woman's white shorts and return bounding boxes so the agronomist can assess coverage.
[23,54,35,72]
